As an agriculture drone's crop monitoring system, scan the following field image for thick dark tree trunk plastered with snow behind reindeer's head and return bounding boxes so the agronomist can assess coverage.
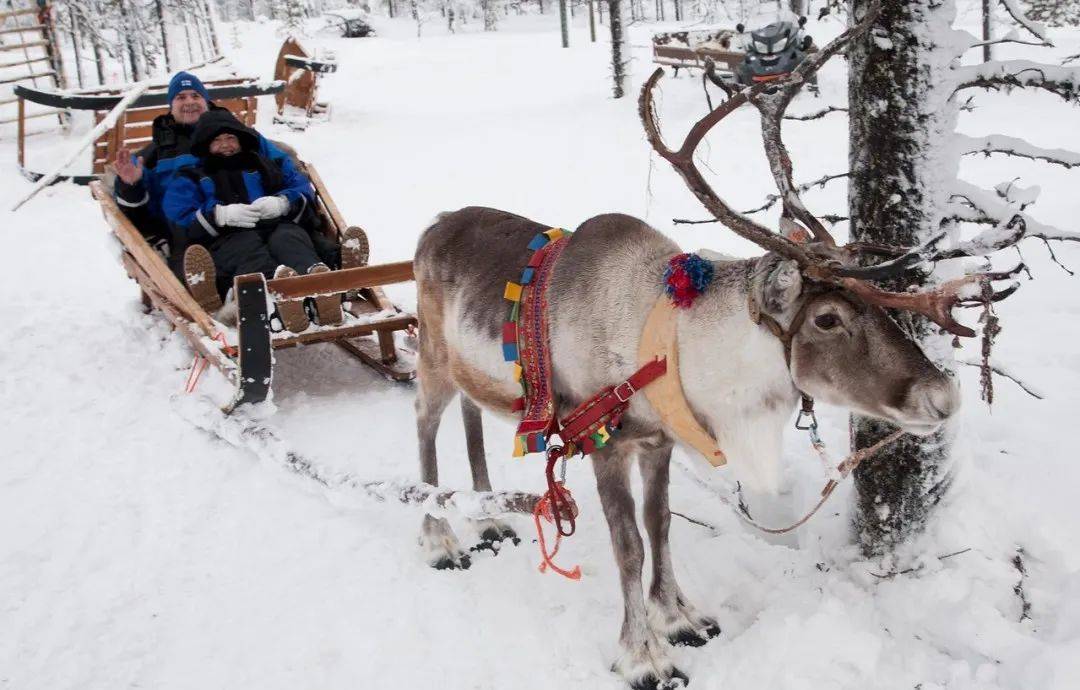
[848,0,959,555]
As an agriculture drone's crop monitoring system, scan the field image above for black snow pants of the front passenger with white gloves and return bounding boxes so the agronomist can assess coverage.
[207,222,323,295]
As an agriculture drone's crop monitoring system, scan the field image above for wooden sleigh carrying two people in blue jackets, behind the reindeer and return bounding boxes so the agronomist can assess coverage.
[90,113,417,410]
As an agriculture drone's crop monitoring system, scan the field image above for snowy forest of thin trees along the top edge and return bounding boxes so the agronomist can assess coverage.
[39,0,1080,86]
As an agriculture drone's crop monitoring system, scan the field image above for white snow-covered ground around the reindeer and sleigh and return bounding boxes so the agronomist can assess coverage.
[0,6,1080,690]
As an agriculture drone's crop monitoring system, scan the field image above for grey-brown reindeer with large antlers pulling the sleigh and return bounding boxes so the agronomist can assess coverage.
[415,4,1023,688]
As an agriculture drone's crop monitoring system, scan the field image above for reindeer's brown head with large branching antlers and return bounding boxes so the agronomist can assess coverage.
[638,2,1025,433]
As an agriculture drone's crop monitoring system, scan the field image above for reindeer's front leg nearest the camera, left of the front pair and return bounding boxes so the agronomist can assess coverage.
[593,439,689,690]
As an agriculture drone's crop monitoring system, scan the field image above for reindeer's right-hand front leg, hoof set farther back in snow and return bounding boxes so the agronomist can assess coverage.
[639,443,720,647]
